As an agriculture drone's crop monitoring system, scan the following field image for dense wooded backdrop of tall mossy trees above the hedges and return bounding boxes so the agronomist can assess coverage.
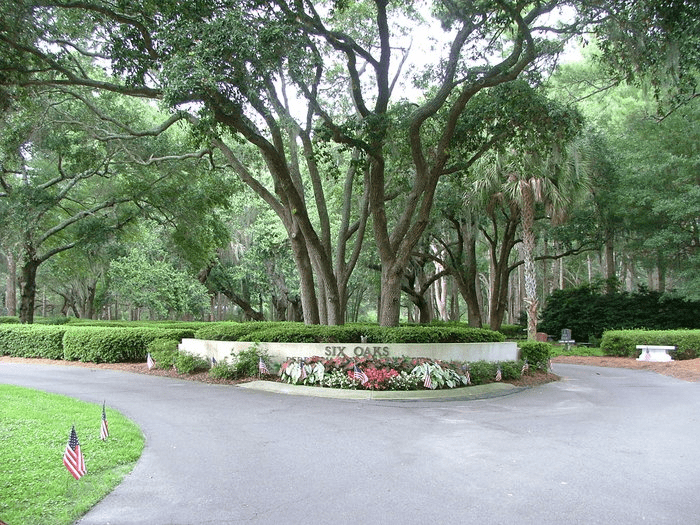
[0,0,700,336]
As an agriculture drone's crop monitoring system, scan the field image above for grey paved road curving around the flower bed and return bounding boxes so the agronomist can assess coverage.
[0,363,700,525]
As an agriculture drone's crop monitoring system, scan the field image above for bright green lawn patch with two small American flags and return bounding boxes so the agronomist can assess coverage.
[0,385,144,525]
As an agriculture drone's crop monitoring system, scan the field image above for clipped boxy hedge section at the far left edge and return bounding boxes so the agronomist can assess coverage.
[0,324,67,359]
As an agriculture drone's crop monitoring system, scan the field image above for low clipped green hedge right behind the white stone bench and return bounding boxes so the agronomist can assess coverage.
[600,330,700,359]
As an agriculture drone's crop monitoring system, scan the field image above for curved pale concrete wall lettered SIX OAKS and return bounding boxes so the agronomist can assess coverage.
[178,339,519,362]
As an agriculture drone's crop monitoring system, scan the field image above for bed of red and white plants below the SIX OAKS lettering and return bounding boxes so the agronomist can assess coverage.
[279,357,527,390]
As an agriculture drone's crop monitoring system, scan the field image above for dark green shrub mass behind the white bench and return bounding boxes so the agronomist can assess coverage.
[539,285,700,341]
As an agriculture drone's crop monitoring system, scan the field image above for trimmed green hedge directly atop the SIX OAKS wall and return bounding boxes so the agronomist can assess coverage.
[195,322,505,344]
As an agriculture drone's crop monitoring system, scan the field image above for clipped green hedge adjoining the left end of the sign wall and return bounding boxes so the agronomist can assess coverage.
[63,326,194,363]
